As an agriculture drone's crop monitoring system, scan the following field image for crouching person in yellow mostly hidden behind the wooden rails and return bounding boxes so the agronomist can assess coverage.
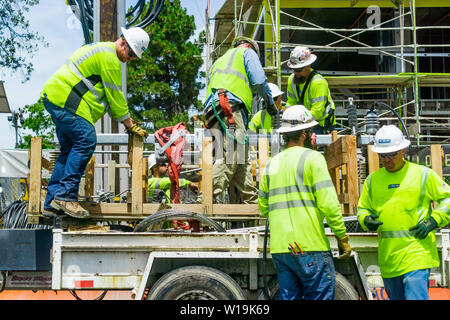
[148,163,198,203]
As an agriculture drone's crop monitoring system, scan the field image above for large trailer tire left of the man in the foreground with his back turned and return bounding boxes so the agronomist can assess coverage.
[147,266,247,300]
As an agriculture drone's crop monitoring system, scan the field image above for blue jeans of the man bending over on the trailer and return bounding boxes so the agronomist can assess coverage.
[43,98,97,211]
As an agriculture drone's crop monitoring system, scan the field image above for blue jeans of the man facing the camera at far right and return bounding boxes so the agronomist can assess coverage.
[383,269,430,300]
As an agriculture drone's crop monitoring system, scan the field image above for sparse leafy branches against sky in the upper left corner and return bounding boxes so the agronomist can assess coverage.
[0,0,48,82]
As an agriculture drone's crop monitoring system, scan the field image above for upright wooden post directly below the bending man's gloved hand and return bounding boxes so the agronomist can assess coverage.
[128,134,144,215]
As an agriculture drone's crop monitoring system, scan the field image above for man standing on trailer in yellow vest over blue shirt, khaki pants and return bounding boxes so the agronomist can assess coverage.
[199,37,276,204]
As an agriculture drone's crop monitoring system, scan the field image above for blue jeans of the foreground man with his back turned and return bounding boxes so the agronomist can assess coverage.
[272,251,336,300]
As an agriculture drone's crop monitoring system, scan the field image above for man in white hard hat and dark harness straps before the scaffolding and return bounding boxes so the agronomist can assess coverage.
[286,47,336,134]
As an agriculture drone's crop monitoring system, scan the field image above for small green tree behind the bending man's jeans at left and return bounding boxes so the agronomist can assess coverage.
[19,99,55,149]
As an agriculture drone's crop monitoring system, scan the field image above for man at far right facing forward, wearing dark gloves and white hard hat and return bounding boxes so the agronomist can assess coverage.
[358,125,450,300]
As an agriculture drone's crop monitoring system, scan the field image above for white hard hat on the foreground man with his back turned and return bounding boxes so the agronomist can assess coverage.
[277,104,318,133]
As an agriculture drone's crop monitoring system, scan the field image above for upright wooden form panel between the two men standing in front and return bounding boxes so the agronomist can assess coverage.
[325,135,359,215]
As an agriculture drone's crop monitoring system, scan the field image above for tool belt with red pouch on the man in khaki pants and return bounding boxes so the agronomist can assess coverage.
[203,89,247,130]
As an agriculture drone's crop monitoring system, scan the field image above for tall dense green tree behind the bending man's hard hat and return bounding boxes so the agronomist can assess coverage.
[127,0,205,132]
